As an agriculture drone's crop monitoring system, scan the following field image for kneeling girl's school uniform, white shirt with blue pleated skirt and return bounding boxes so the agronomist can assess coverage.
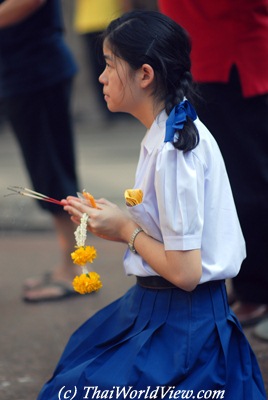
[38,112,266,400]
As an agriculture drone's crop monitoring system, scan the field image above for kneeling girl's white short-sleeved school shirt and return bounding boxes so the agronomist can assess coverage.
[124,111,246,283]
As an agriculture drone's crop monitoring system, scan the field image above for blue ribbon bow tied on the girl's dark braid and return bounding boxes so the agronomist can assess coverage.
[164,100,197,142]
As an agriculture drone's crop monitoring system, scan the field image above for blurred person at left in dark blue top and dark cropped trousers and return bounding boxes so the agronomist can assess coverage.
[0,0,78,302]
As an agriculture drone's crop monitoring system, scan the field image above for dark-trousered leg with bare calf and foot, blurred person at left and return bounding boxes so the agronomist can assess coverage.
[3,82,81,300]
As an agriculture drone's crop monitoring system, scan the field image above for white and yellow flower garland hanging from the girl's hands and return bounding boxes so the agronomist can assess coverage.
[71,213,102,294]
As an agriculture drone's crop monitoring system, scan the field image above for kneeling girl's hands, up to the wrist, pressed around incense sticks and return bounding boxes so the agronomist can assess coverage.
[63,196,137,242]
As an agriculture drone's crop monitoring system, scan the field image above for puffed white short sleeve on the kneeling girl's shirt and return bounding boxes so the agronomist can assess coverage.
[155,143,205,250]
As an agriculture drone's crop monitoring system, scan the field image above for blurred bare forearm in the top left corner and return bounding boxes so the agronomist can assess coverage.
[0,0,46,29]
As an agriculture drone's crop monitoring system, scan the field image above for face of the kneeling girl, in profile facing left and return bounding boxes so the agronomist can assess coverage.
[99,42,138,115]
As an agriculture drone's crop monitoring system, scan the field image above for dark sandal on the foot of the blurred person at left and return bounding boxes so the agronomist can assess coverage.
[23,280,79,303]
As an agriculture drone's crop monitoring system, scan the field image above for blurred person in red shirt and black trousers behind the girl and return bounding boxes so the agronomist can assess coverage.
[158,0,268,339]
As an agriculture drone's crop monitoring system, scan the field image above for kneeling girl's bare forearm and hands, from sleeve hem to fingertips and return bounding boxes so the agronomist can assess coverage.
[64,197,202,291]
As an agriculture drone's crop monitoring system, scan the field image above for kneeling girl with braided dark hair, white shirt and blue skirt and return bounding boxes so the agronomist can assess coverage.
[38,11,266,400]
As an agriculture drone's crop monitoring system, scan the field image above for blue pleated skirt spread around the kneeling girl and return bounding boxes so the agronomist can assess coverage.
[38,281,266,400]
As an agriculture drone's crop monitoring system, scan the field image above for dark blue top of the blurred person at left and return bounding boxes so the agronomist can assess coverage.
[0,0,77,98]
